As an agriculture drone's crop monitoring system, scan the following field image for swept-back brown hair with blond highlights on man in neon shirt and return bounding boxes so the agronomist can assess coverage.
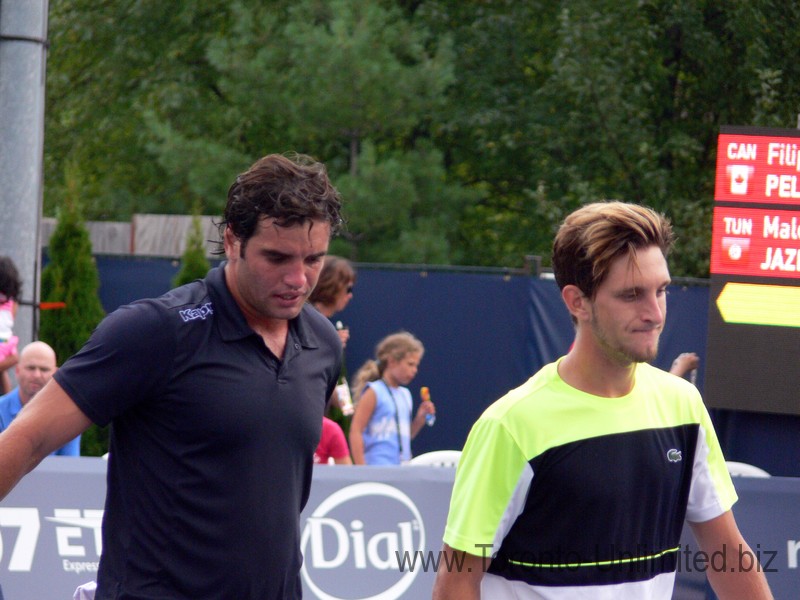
[553,201,675,298]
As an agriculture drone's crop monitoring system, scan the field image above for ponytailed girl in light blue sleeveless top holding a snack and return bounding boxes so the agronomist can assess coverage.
[350,331,436,465]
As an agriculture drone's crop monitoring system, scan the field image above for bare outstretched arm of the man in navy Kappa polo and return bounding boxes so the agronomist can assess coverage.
[0,380,92,499]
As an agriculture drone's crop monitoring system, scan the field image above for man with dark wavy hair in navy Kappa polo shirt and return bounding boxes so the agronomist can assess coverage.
[0,155,341,600]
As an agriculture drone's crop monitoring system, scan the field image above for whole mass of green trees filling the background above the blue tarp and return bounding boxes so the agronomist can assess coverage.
[45,0,800,277]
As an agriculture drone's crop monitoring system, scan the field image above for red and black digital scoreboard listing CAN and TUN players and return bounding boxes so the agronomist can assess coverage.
[704,127,800,414]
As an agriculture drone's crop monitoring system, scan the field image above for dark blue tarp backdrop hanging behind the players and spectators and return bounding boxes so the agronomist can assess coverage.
[87,256,800,476]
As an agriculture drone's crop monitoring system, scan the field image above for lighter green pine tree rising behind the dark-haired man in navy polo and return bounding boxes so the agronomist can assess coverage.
[200,0,468,264]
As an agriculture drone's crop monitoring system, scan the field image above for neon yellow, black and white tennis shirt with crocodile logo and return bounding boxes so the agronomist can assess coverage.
[444,363,737,600]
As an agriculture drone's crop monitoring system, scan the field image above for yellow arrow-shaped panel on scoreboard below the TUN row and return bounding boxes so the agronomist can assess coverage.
[717,282,800,327]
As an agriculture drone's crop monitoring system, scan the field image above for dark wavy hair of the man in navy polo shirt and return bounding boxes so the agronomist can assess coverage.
[216,154,342,254]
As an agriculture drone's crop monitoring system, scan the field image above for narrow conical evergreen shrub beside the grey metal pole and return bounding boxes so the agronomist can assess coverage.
[39,167,108,456]
